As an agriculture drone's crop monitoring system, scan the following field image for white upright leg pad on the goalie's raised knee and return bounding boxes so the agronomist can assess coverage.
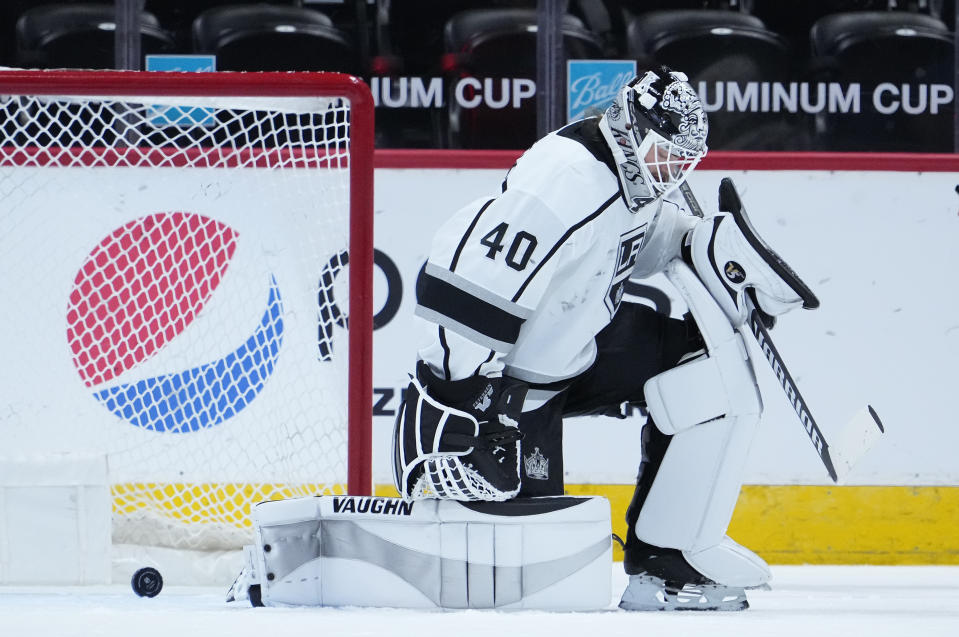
[636,261,769,587]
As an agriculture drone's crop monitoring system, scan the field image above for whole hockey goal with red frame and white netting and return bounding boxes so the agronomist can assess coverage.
[0,71,373,549]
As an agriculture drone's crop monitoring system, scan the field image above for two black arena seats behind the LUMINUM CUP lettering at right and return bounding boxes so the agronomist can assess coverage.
[627,9,955,152]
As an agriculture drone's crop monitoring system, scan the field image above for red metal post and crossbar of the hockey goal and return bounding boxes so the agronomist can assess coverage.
[0,70,374,495]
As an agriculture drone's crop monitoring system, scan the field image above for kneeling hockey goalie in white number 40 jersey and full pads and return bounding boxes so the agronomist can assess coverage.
[230,67,818,611]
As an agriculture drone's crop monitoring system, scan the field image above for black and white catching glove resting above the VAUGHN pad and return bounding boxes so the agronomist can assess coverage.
[393,362,527,501]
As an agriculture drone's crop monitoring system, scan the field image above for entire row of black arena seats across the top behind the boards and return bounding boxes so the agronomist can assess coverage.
[3,0,954,151]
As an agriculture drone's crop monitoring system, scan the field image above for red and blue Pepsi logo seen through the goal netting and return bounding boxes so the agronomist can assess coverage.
[67,212,283,433]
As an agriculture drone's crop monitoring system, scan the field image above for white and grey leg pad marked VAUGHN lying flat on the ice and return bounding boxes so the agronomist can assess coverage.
[227,496,612,610]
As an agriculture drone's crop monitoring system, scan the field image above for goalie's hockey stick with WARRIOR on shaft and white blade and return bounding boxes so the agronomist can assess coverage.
[680,178,885,483]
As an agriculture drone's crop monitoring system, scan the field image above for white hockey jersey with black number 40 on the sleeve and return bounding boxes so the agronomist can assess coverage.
[416,118,682,386]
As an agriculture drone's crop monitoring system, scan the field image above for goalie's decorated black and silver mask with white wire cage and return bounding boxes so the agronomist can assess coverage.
[600,66,709,212]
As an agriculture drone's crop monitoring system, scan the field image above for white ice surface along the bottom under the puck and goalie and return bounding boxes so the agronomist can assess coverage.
[0,564,959,637]
